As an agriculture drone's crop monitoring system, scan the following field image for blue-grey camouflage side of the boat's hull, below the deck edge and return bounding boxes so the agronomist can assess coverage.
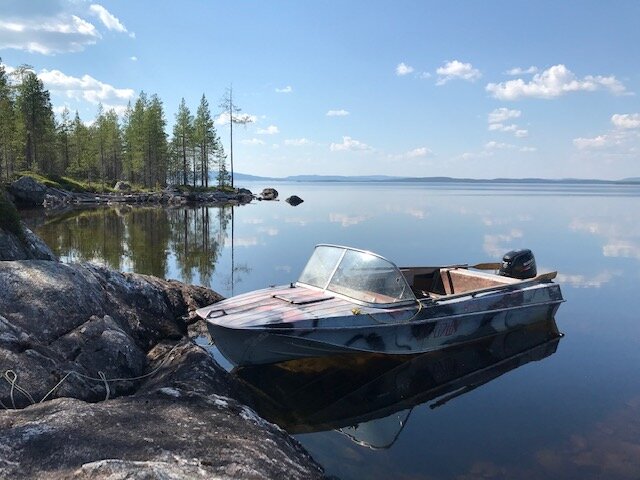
[207,295,562,365]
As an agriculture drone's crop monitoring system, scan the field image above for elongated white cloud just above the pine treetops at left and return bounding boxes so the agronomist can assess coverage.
[38,69,135,108]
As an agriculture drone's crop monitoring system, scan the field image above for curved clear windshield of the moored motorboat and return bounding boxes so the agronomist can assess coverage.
[298,245,415,304]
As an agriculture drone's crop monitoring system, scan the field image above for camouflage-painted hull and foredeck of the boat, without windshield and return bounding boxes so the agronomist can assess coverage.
[198,282,563,365]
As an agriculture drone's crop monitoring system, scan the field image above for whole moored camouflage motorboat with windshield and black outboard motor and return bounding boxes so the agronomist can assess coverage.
[196,244,563,365]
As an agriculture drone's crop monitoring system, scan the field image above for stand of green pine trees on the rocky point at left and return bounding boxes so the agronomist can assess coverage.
[0,59,231,188]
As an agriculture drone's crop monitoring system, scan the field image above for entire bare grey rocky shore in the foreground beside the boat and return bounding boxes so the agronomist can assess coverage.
[0,205,323,479]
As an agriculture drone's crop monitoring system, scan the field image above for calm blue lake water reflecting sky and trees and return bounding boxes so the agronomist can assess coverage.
[24,183,640,479]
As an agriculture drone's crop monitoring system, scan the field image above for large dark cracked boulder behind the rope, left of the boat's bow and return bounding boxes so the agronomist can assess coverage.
[0,260,221,407]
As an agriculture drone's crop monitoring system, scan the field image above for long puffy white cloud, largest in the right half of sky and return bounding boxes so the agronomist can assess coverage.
[486,64,626,100]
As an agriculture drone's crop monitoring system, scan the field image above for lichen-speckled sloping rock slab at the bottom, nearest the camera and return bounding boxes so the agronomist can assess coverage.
[0,341,323,480]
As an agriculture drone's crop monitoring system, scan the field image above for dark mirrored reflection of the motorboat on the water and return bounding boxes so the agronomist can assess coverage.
[234,313,562,448]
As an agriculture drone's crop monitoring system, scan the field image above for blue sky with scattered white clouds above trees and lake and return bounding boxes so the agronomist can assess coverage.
[0,0,640,179]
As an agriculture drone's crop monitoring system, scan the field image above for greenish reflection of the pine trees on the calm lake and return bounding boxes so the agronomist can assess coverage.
[25,206,239,285]
